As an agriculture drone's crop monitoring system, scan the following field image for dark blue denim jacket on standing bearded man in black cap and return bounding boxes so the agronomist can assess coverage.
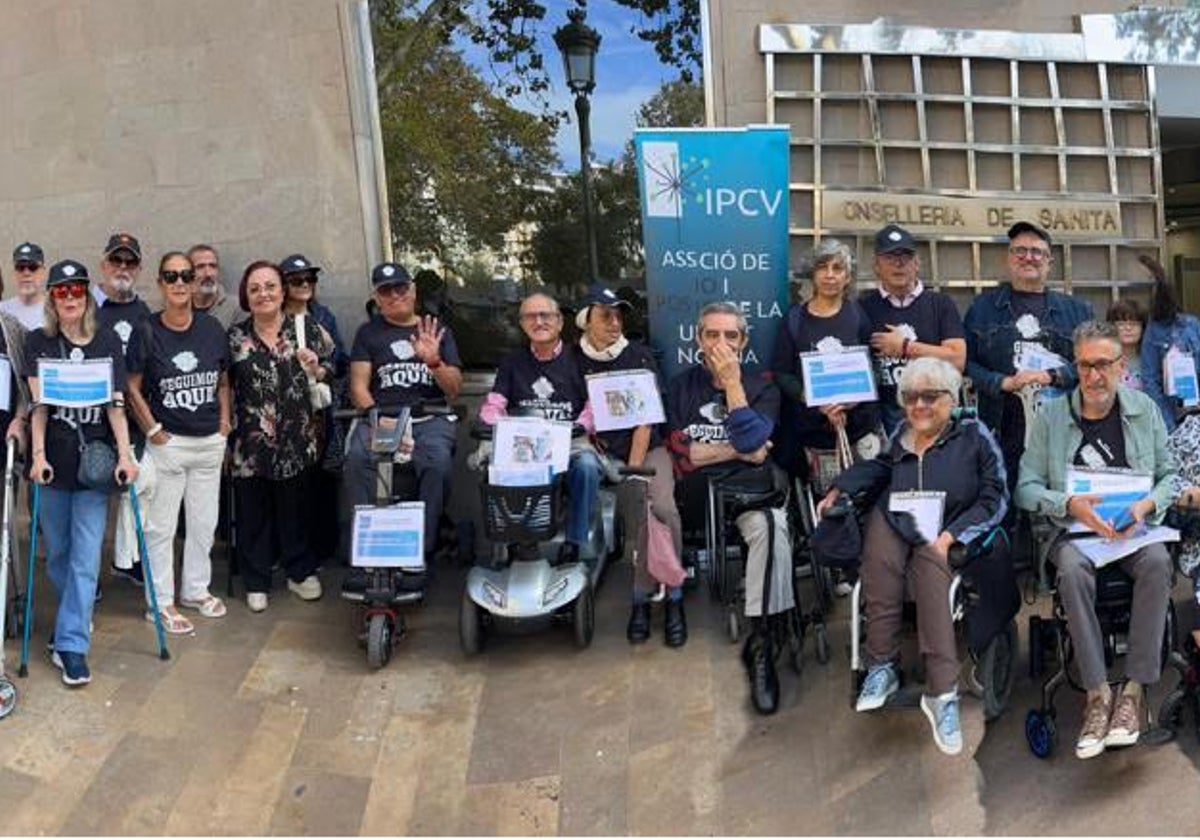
[962,283,1092,431]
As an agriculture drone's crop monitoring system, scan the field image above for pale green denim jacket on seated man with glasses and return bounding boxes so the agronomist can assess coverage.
[1016,388,1178,523]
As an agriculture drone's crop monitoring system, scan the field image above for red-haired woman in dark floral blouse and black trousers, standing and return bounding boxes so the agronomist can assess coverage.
[229,260,334,612]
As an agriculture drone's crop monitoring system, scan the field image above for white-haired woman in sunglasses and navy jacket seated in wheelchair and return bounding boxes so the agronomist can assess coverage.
[820,359,1008,755]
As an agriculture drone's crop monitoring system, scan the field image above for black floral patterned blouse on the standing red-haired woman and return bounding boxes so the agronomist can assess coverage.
[229,316,334,481]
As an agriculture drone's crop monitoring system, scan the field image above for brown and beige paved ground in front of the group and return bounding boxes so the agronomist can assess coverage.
[0,542,1200,835]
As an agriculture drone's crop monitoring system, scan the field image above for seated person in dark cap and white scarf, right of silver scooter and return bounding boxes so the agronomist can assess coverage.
[575,284,688,648]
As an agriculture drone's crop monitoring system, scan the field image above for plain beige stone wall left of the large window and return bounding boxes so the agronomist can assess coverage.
[0,0,368,332]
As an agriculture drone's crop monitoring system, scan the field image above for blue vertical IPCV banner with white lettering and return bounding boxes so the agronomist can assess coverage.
[634,126,788,378]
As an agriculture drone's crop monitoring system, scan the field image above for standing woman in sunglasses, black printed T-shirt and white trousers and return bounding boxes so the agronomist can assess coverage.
[128,251,233,634]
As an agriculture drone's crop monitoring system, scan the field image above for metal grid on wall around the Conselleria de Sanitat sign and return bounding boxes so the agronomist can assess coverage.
[764,36,1164,311]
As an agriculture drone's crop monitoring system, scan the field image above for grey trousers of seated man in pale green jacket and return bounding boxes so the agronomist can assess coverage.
[1054,541,1171,691]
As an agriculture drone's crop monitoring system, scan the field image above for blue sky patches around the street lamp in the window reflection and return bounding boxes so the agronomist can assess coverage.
[461,0,678,170]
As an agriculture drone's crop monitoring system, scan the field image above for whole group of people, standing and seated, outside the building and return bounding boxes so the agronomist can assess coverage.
[9,222,1200,757]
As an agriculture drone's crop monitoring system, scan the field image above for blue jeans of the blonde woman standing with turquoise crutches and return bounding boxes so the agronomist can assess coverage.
[41,487,108,654]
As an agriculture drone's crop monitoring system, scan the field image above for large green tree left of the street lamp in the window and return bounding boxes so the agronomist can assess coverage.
[379,22,558,266]
